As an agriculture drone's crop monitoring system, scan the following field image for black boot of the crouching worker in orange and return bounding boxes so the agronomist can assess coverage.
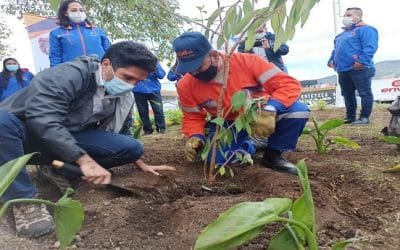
[261,148,297,175]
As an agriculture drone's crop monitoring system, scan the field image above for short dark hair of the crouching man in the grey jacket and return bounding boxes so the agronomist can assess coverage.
[101,41,157,72]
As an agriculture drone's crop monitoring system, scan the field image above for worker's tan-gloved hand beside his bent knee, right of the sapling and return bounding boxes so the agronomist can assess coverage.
[250,110,276,137]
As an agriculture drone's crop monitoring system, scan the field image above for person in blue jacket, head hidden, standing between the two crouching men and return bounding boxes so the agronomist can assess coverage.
[133,63,166,135]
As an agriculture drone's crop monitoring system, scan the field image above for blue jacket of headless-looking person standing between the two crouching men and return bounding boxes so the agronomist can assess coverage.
[132,63,165,94]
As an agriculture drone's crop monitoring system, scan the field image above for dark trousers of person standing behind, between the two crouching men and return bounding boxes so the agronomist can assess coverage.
[133,92,166,133]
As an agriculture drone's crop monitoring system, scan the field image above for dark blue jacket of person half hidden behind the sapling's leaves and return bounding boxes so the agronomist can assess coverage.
[238,32,289,72]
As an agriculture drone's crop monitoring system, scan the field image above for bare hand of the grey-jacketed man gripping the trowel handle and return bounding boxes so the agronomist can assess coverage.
[76,155,111,184]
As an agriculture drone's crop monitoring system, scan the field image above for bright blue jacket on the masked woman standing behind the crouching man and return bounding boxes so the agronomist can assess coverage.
[49,22,110,67]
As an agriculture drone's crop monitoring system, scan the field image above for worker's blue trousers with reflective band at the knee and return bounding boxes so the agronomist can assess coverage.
[207,101,310,164]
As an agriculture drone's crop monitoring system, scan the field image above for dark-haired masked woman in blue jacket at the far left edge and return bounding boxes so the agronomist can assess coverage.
[0,58,33,102]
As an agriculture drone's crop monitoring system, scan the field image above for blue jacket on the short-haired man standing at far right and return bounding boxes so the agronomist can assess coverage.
[328,22,378,72]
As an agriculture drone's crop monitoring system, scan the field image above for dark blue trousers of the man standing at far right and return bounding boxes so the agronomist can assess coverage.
[339,68,375,120]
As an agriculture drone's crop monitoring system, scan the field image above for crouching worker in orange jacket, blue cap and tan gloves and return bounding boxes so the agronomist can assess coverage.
[172,31,309,175]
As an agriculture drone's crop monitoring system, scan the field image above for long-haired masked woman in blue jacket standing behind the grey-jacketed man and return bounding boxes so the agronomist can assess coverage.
[49,0,110,67]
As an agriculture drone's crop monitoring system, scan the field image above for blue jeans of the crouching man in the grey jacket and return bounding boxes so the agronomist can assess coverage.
[0,110,143,201]
